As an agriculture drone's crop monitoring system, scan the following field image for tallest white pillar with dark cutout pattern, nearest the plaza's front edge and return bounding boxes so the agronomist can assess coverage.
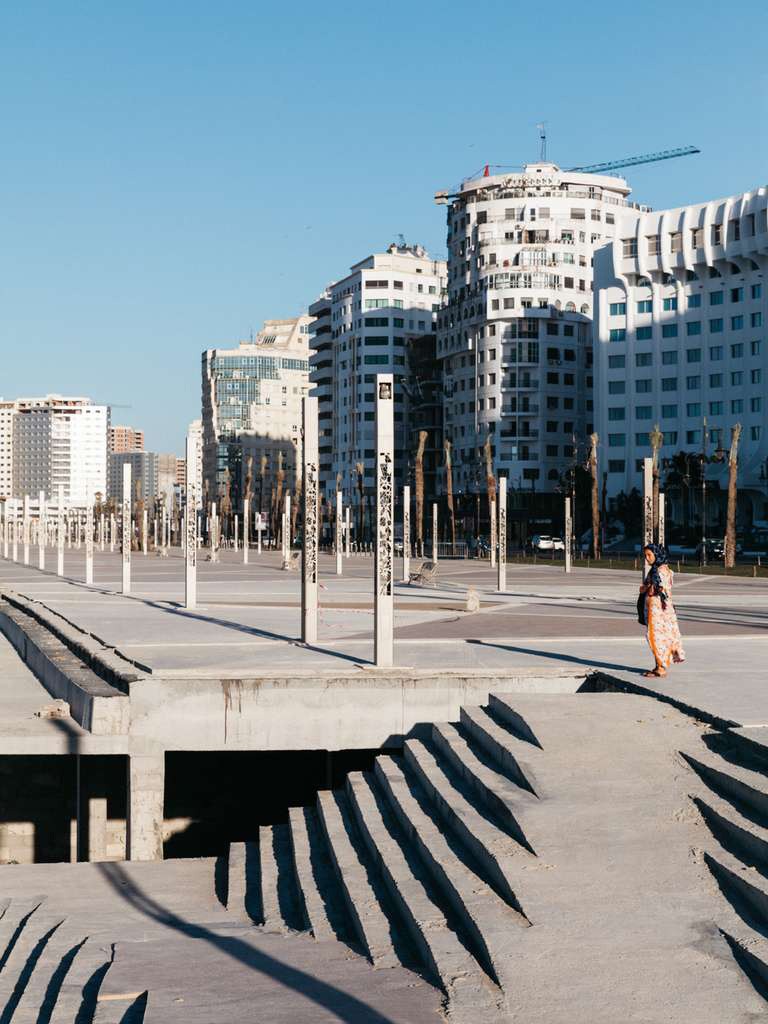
[374,374,393,669]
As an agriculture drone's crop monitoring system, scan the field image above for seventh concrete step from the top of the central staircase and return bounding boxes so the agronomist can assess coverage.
[317,790,400,967]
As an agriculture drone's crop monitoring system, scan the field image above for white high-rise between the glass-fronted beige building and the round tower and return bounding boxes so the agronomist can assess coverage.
[309,244,446,495]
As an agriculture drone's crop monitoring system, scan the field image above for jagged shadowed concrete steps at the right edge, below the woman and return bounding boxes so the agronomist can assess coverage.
[682,729,768,998]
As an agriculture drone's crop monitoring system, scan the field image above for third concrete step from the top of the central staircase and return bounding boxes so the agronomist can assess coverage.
[432,723,536,853]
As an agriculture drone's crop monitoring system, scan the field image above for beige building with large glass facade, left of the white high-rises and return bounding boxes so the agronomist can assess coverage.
[203,315,310,505]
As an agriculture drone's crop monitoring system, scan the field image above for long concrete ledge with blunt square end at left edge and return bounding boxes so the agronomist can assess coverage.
[0,603,130,735]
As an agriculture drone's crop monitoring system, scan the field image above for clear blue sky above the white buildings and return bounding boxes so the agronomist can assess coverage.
[0,0,768,453]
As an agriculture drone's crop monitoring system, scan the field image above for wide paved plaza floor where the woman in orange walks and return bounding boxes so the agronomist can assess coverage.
[0,550,768,726]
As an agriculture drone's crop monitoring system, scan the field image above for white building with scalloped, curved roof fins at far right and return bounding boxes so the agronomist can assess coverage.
[595,187,768,521]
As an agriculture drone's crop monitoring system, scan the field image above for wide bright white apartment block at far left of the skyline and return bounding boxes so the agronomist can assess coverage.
[7,394,110,507]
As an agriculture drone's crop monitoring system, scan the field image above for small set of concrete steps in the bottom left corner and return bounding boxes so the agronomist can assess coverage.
[0,896,143,1024]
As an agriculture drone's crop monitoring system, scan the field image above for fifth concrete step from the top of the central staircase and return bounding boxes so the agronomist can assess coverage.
[375,757,527,987]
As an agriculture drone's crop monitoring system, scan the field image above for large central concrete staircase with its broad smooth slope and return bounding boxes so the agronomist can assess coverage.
[226,693,768,1024]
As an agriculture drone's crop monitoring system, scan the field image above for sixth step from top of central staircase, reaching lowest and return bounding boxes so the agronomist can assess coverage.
[346,772,506,1020]
